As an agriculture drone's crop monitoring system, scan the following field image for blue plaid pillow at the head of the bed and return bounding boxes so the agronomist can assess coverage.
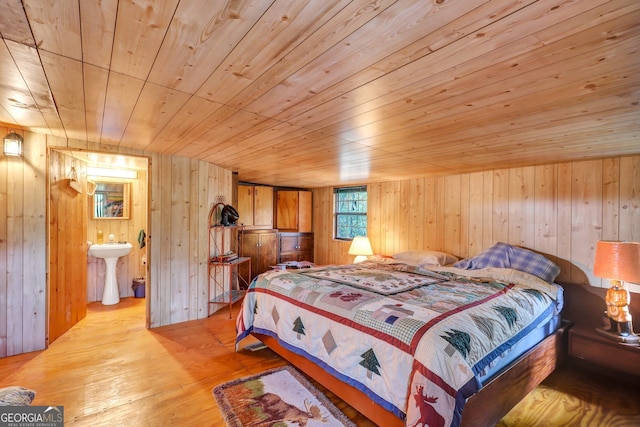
[453,242,560,283]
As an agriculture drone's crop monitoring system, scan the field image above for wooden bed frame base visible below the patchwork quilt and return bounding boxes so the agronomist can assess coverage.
[252,325,567,427]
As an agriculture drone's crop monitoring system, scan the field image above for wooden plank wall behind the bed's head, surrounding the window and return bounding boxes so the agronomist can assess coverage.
[313,156,640,292]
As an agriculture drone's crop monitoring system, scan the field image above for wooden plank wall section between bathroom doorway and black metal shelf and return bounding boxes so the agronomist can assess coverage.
[148,154,233,327]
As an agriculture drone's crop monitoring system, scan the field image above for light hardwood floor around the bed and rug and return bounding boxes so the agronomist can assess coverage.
[0,298,640,427]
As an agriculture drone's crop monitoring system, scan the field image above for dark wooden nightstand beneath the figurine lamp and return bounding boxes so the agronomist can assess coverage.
[569,325,640,377]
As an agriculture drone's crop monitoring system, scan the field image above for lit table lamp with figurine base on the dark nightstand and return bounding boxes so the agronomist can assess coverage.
[593,240,640,344]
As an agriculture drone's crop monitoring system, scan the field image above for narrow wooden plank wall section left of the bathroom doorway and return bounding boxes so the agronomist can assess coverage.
[0,126,47,357]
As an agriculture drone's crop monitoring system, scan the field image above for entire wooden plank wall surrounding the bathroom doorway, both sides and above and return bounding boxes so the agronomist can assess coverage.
[0,127,233,357]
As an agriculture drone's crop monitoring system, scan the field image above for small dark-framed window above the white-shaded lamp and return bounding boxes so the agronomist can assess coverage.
[333,186,367,240]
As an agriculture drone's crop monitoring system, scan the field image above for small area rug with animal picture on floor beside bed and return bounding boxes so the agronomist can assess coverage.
[213,366,355,427]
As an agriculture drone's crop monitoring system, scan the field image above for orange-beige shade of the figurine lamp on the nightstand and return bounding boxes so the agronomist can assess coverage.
[593,240,640,283]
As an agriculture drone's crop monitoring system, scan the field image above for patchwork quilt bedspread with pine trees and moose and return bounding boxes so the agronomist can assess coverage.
[236,261,558,426]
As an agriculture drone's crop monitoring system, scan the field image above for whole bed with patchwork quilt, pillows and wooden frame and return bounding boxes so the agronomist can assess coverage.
[236,243,563,426]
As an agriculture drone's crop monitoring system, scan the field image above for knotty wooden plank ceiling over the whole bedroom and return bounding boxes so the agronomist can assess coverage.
[0,0,640,187]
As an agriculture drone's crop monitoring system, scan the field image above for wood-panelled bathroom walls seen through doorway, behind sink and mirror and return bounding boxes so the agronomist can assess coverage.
[47,148,150,345]
